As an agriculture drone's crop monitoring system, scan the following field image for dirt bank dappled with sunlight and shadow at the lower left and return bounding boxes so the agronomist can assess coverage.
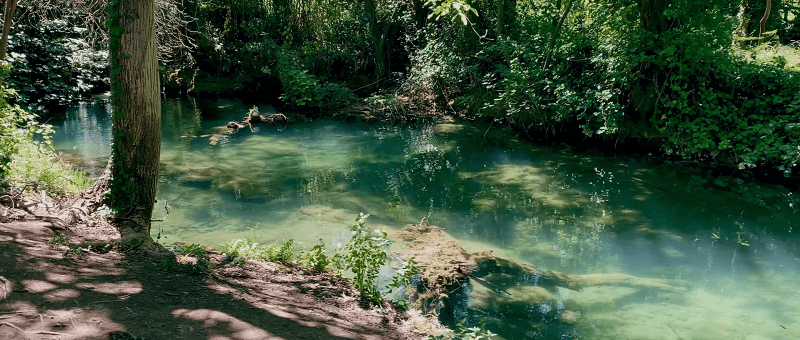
[0,221,420,340]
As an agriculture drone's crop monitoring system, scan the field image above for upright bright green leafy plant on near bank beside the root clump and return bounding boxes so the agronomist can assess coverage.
[342,214,390,302]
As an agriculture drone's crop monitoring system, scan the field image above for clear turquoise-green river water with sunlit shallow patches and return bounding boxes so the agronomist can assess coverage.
[50,100,800,340]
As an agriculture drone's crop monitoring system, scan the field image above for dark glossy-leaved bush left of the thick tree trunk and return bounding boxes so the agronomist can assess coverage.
[8,12,108,113]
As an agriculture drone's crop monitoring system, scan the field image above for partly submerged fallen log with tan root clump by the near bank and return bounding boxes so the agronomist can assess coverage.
[399,220,688,323]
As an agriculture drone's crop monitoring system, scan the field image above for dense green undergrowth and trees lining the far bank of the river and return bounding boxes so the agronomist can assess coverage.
[12,0,800,181]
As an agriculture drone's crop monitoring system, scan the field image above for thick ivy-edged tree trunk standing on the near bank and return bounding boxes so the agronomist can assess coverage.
[110,0,161,244]
